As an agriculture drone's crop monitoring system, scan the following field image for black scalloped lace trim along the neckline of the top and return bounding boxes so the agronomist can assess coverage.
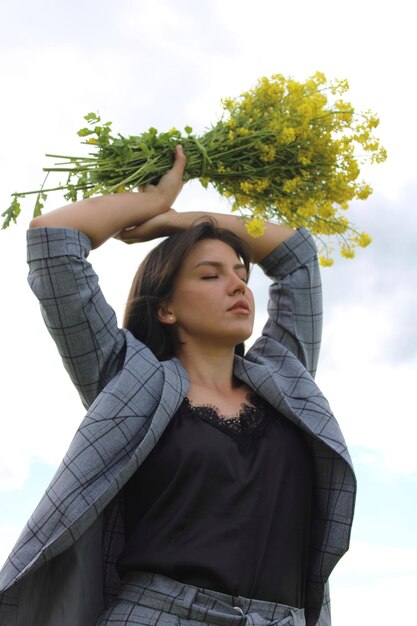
[183,394,266,448]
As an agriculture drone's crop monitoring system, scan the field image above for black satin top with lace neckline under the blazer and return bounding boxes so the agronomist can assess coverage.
[118,398,313,607]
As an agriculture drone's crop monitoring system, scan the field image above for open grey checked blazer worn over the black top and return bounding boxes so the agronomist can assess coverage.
[0,228,356,626]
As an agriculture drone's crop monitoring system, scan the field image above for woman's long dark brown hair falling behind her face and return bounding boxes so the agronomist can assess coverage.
[123,218,251,361]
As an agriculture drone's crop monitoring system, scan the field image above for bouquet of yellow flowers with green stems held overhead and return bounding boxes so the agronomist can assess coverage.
[2,72,386,265]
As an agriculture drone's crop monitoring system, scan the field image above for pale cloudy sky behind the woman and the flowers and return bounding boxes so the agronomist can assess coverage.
[0,0,417,626]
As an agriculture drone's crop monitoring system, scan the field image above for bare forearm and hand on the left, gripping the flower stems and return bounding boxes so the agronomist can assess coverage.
[30,146,186,248]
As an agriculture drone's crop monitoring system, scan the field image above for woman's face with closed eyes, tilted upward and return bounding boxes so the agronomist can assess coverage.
[160,239,255,347]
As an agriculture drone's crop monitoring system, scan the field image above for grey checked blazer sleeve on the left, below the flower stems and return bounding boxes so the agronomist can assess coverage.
[27,228,126,408]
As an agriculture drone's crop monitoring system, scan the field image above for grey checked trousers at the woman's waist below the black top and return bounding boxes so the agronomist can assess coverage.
[96,572,305,626]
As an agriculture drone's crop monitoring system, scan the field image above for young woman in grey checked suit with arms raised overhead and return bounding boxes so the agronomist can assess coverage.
[0,147,355,626]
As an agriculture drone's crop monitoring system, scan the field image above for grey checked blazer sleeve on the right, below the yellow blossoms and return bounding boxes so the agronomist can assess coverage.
[248,228,322,376]
